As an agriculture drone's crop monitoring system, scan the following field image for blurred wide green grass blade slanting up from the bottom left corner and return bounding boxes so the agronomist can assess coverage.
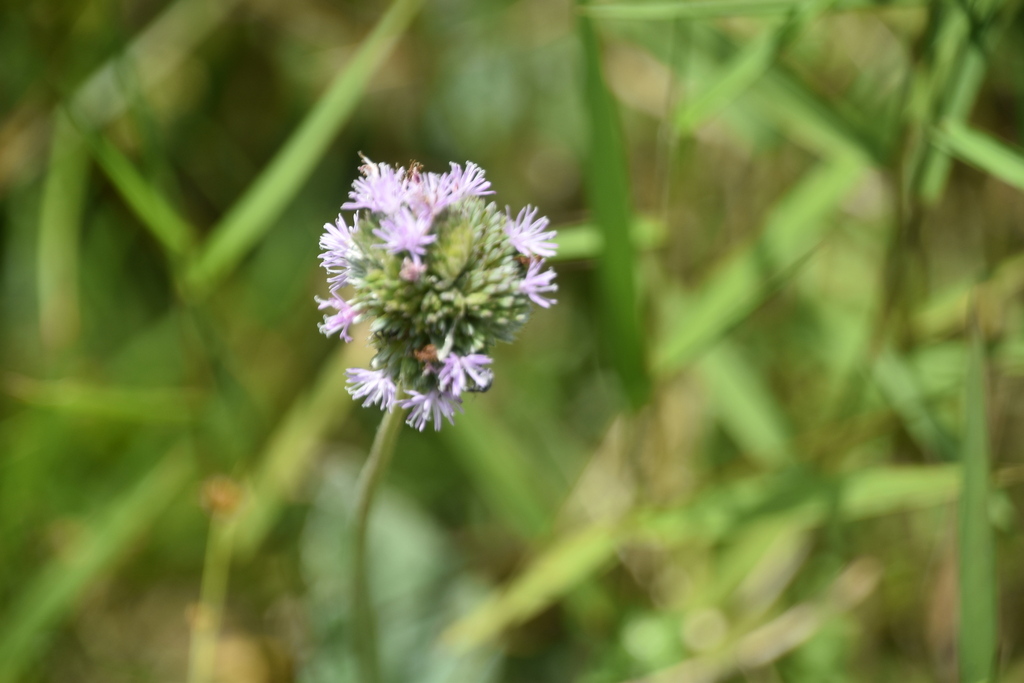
[0,447,193,683]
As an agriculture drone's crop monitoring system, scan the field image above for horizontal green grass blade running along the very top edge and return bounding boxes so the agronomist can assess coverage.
[585,0,926,20]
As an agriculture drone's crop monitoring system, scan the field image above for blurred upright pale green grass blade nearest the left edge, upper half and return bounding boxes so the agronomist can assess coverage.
[36,113,89,348]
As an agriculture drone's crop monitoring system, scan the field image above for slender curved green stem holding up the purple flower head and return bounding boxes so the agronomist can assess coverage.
[352,408,404,683]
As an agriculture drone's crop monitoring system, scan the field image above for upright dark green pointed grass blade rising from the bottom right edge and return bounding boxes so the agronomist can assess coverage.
[957,322,998,683]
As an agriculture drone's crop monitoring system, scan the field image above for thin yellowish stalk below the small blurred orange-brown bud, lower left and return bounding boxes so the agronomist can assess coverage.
[188,514,236,683]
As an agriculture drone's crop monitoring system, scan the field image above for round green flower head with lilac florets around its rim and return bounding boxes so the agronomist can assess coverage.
[317,158,558,431]
